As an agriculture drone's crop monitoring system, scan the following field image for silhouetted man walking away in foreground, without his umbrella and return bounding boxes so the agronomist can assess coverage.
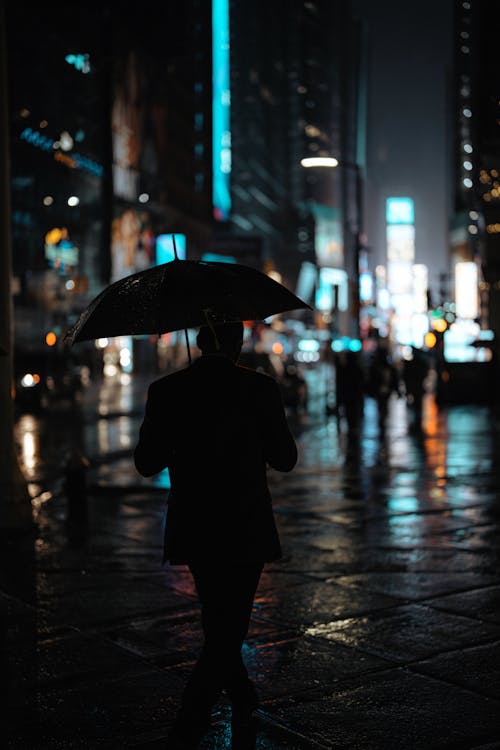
[134,323,297,750]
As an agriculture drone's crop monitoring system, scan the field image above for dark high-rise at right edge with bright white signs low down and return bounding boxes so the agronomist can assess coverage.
[435,0,500,400]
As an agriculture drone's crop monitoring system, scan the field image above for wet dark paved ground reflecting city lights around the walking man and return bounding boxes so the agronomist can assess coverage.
[0,378,500,750]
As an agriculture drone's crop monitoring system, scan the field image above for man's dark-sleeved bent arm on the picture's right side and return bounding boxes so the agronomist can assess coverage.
[263,378,297,471]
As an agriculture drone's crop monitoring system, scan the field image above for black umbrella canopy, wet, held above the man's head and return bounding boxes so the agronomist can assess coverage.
[65,259,311,344]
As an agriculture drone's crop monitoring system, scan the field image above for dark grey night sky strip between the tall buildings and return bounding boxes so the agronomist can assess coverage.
[353,0,453,300]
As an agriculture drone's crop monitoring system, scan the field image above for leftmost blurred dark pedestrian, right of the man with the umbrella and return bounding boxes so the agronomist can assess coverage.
[335,350,365,437]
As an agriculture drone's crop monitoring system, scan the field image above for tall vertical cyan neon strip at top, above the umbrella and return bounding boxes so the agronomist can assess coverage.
[212,0,231,221]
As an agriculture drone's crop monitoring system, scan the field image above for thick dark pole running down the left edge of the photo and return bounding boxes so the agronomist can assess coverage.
[0,4,34,532]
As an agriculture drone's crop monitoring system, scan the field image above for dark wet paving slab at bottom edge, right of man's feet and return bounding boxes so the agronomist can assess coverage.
[266,670,500,750]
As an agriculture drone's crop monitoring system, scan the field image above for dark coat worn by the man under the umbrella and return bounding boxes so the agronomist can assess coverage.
[134,355,297,564]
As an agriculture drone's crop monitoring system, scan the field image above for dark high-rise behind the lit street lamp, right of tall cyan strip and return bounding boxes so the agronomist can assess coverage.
[230,0,366,334]
